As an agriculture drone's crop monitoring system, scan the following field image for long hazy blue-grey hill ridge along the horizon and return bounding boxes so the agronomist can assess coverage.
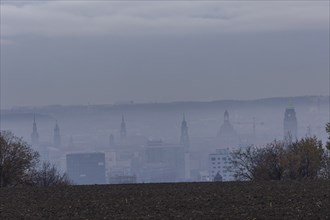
[1,96,330,115]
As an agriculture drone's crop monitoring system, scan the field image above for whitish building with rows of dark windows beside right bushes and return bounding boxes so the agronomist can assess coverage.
[208,148,234,181]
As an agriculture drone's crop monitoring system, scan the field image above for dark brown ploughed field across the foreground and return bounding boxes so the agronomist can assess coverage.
[0,181,330,220]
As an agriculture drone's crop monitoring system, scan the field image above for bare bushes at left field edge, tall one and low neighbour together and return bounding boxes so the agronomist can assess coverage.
[0,131,70,188]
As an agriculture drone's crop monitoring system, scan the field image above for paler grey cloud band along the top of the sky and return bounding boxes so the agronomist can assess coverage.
[1,1,329,37]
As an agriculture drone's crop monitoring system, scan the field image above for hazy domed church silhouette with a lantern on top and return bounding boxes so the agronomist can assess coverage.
[218,110,240,147]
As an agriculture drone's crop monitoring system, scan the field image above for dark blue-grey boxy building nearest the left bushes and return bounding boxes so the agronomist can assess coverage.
[66,153,106,185]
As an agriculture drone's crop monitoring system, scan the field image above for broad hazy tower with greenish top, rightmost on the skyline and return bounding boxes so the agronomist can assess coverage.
[283,106,298,141]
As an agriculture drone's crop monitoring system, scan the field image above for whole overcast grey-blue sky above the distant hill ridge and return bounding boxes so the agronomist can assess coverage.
[0,0,329,108]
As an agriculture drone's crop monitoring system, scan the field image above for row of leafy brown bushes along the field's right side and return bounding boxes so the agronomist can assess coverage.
[228,123,330,181]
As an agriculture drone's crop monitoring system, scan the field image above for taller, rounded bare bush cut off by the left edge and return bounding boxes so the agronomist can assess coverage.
[0,131,39,187]
